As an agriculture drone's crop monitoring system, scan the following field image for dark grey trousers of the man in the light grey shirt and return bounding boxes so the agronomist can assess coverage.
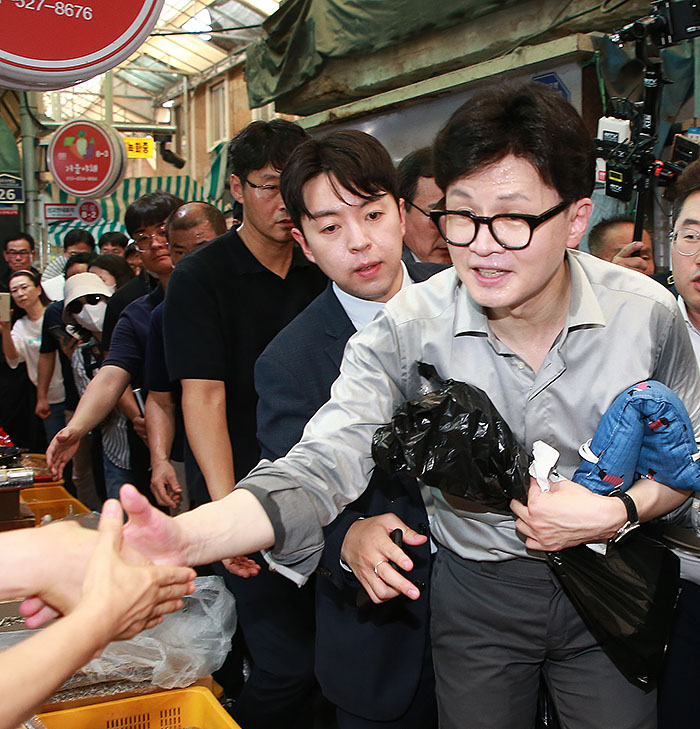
[431,549,656,729]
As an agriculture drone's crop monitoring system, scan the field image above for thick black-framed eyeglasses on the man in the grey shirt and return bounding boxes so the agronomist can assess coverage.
[430,200,571,251]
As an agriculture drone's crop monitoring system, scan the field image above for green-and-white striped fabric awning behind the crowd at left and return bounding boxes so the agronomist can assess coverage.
[47,175,221,246]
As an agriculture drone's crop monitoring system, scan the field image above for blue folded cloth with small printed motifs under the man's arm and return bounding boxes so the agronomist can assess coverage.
[572,380,700,494]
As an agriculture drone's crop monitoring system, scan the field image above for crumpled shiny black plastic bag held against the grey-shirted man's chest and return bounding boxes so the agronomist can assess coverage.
[372,362,530,511]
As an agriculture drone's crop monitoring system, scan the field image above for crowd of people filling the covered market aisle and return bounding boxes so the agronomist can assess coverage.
[0,79,700,729]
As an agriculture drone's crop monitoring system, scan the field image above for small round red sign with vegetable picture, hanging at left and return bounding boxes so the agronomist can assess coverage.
[48,119,126,197]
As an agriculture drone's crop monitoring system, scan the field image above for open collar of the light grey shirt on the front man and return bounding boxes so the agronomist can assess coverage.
[453,249,605,336]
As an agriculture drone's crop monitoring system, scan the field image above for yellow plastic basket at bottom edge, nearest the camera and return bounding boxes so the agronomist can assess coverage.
[39,686,241,729]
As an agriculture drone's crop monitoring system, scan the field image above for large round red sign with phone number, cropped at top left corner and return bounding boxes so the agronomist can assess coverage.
[0,0,163,89]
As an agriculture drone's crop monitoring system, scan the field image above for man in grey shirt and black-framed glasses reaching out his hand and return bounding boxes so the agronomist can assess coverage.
[116,83,700,729]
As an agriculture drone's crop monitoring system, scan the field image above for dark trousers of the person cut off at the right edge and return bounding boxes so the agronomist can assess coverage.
[659,580,700,729]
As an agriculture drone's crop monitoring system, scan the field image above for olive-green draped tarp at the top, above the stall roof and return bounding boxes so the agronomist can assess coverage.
[246,0,518,108]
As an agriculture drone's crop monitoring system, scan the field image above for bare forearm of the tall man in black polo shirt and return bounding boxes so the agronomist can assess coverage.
[182,380,235,500]
